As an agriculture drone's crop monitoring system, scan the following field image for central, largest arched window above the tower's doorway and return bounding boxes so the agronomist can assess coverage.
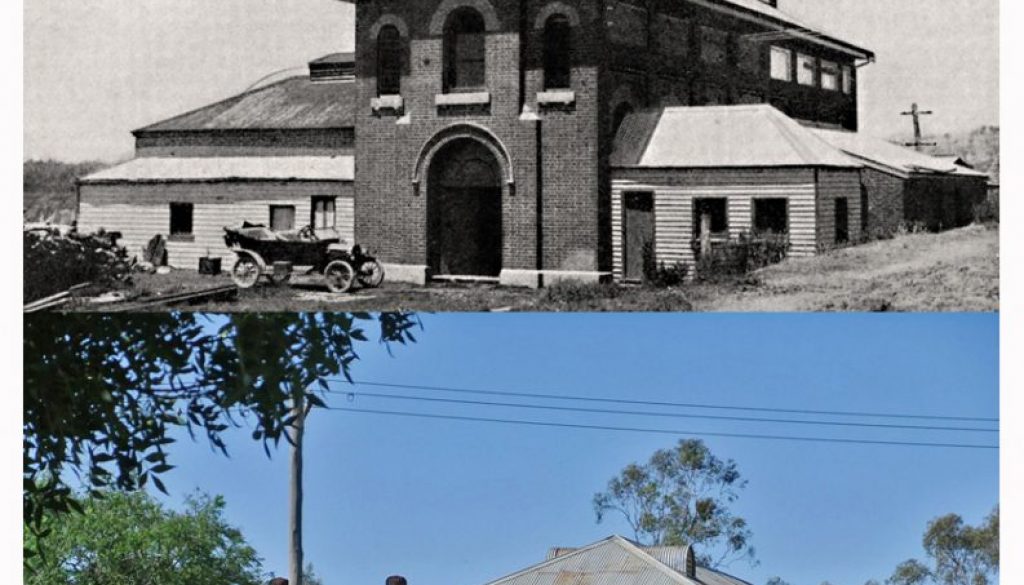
[444,8,486,91]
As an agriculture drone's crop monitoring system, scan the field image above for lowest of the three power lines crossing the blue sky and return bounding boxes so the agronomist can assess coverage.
[327,406,999,450]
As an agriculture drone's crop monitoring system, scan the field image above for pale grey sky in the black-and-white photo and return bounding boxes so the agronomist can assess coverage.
[24,0,999,161]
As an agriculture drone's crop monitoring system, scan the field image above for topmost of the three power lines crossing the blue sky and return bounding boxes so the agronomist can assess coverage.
[327,378,999,422]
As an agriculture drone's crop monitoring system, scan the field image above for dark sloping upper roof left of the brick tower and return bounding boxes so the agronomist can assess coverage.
[135,75,355,132]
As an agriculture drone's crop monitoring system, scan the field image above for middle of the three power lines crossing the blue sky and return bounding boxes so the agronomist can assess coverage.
[329,390,999,432]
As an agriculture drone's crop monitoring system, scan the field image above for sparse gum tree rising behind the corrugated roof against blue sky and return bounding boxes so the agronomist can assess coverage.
[594,440,754,568]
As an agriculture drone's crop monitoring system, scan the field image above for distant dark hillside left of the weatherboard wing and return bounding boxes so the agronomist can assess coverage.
[22,160,106,223]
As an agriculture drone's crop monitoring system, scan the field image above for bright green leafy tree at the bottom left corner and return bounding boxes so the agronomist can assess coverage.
[25,492,263,585]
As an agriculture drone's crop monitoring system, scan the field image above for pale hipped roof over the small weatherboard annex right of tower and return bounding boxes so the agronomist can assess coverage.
[611,103,862,168]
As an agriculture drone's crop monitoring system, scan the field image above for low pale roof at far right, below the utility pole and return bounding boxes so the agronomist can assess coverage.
[810,128,988,178]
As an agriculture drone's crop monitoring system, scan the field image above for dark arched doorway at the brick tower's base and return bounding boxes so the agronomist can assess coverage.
[427,138,502,277]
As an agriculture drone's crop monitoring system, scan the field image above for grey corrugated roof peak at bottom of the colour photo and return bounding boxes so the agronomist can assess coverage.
[479,536,751,585]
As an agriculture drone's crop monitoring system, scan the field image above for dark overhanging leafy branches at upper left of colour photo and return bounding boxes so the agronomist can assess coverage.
[23,314,417,560]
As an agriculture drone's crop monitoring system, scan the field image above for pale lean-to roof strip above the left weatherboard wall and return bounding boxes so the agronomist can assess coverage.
[81,156,354,183]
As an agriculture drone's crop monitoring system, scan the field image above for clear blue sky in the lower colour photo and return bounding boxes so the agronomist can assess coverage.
[136,315,999,585]
